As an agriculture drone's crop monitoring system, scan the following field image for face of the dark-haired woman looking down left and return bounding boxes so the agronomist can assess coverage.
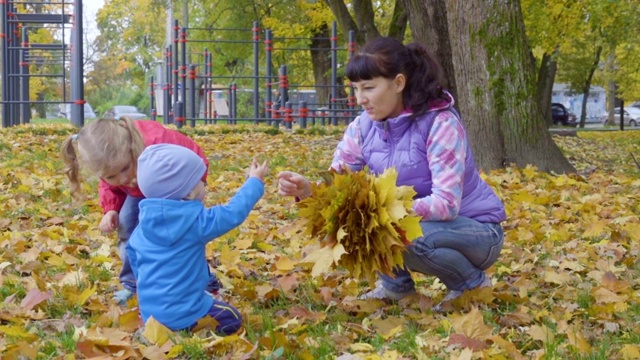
[351,74,405,121]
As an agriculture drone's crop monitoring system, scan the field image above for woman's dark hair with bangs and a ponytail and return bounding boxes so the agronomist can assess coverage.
[347,37,448,116]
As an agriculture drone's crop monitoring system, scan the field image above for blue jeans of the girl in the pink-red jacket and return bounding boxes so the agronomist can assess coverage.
[118,195,143,293]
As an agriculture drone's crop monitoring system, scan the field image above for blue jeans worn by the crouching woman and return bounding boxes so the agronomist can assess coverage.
[380,216,504,292]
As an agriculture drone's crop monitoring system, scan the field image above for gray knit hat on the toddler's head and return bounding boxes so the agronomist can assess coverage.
[137,144,207,200]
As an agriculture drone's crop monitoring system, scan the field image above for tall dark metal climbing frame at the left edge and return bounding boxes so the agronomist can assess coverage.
[0,0,85,127]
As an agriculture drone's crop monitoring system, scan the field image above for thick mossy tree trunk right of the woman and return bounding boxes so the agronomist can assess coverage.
[444,0,575,173]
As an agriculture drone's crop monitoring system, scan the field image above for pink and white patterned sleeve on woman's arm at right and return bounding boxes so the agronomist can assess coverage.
[413,111,467,221]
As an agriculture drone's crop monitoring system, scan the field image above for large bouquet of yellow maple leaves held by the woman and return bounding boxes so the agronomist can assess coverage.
[299,168,422,283]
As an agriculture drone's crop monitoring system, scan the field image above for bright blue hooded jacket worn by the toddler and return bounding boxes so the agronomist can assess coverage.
[127,177,264,330]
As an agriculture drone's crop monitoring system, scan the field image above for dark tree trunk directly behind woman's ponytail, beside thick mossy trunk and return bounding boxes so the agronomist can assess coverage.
[399,0,457,99]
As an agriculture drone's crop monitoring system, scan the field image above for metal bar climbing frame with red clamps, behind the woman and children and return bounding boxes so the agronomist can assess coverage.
[150,20,357,128]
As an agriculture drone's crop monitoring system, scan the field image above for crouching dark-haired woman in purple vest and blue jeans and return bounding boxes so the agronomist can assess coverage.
[278,37,506,311]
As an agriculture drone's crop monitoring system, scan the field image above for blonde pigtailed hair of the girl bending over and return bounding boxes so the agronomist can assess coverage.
[60,117,144,197]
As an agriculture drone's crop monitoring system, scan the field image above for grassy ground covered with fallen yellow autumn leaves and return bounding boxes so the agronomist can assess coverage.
[0,125,640,359]
